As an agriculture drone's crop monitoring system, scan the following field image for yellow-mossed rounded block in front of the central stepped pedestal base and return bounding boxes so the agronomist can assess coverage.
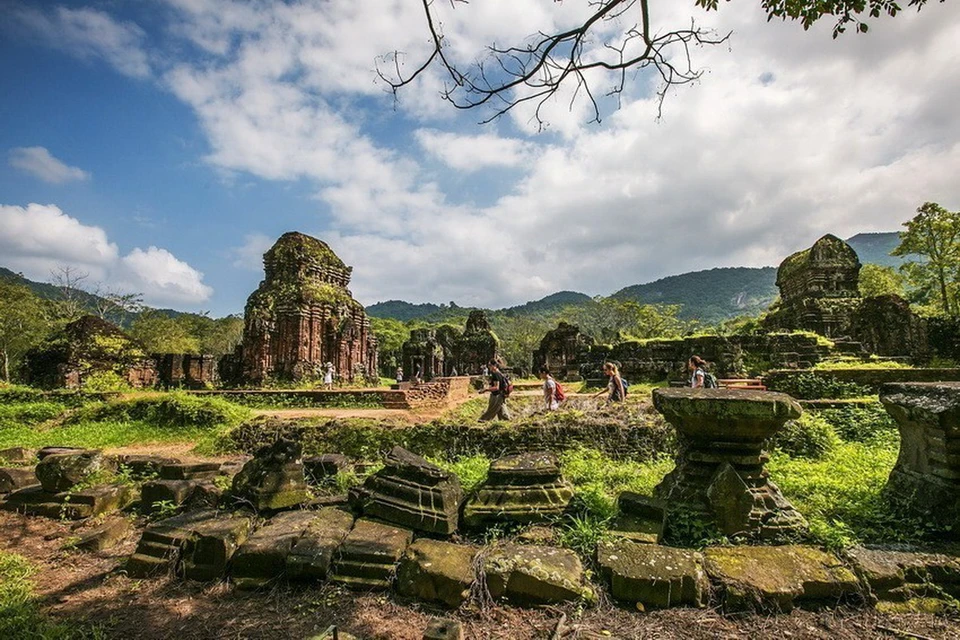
[483,544,595,604]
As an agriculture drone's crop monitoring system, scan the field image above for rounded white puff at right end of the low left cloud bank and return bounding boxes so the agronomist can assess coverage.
[116,247,213,305]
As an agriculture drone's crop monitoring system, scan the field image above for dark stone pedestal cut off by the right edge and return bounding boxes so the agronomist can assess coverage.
[880,382,960,536]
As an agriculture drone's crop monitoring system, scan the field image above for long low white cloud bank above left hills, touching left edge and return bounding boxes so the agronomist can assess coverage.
[0,204,213,305]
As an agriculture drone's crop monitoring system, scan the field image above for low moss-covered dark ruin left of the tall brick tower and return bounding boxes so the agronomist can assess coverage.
[24,316,157,389]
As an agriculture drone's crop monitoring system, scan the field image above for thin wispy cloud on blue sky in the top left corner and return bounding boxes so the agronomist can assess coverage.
[10,6,150,78]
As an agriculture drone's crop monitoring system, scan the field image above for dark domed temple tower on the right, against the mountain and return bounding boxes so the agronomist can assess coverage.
[764,234,860,338]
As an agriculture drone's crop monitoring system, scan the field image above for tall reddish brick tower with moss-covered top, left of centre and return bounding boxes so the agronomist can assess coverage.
[243,231,377,384]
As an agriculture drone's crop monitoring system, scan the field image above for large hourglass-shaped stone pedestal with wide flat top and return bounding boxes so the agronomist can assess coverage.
[653,388,806,539]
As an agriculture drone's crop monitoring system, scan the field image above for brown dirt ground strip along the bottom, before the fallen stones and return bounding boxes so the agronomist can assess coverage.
[0,512,960,640]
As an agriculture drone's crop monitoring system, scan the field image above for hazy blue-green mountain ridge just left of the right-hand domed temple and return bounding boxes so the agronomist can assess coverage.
[613,267,778,324]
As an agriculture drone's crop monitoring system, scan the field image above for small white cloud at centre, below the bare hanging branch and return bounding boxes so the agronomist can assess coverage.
[416,129,538,172]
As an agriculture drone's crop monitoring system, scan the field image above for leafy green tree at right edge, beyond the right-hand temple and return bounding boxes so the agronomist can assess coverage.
[891,202,960,317]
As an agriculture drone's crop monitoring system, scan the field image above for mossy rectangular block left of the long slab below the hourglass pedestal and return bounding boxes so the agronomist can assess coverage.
[597,540,710,609]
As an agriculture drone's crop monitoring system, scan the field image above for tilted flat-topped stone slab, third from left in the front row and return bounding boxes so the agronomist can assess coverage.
[231,511,317,589]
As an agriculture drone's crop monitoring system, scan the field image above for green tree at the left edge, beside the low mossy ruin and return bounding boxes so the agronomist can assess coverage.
[0,280,50,382]
